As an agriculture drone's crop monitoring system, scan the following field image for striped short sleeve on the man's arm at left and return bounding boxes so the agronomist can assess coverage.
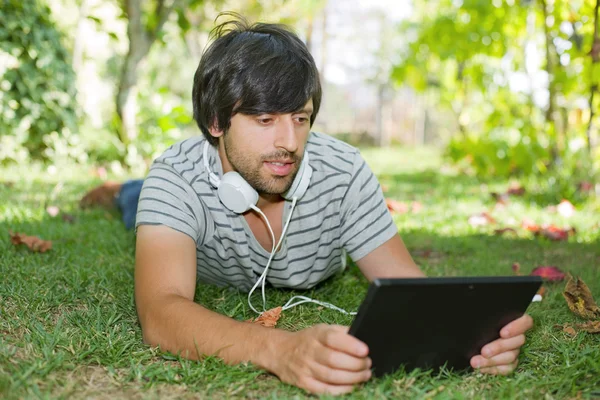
[135,162,206,243]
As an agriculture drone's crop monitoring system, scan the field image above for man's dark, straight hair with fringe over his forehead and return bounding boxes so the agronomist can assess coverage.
[192,13,321,145]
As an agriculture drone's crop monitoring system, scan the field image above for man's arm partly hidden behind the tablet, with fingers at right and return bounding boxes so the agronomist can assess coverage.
[356,231,533,375]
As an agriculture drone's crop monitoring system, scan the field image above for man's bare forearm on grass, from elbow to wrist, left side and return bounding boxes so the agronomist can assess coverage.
[140,295,289,370]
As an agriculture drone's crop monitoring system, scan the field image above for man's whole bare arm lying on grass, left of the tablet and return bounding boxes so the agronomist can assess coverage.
[135,225,371,394]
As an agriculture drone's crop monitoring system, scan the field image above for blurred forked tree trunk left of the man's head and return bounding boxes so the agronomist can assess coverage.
[116,0,174,145]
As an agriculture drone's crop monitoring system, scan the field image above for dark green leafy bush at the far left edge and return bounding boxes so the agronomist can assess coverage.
[0,0,80,162]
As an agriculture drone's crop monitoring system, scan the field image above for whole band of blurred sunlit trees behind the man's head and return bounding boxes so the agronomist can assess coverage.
[0,0,600,196]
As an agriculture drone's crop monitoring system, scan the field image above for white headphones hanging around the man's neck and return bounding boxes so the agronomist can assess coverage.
[204,141,312,214]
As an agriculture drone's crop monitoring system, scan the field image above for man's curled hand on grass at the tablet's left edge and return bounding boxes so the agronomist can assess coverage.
[269,324,371,394]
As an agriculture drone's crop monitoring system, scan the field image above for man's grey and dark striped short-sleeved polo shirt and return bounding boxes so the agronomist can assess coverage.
[136,132,398,291]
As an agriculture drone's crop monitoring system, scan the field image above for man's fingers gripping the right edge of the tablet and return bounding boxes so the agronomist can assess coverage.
[471,314,533,375]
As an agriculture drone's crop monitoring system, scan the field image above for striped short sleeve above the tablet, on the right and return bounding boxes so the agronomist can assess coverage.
[341,151,398,261]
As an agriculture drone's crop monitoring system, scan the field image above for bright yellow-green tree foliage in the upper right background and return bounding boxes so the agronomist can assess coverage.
[392,0,600,195]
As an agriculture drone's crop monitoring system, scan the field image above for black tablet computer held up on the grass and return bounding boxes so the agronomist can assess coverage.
[349,276,542,376]
